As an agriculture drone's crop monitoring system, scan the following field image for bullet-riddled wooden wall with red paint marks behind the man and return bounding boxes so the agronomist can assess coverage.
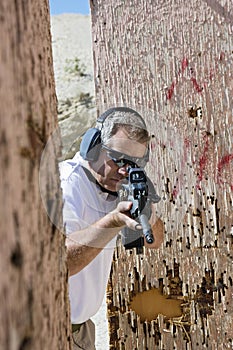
[91,0,233,350]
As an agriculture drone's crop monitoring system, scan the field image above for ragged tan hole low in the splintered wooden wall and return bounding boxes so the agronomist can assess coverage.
[130,288,183,322]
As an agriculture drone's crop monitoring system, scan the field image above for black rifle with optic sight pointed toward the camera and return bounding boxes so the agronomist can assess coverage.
[120,167,160,254]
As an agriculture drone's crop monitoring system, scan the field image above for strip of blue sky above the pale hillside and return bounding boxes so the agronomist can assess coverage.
[49,0,90,15]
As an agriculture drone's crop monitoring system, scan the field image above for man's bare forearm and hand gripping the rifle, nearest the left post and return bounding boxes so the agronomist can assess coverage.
[66,201,138,275]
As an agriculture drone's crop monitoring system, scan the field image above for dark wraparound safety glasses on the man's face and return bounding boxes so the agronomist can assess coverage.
[102,145,147,168]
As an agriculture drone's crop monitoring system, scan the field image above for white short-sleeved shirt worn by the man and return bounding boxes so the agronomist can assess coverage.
[60,153,117,324]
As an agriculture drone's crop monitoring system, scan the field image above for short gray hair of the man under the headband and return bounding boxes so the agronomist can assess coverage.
[101,111,150,145]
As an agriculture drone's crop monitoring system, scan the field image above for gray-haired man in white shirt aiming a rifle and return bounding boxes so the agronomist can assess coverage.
[60,107,163,350]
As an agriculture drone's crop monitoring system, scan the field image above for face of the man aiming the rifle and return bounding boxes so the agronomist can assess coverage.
[91,129,147,192]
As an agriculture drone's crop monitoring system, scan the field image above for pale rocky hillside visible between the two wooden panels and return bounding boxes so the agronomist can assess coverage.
[51,14,96,158]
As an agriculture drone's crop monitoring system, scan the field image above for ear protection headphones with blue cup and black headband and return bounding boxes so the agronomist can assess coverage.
[80,107,149,161]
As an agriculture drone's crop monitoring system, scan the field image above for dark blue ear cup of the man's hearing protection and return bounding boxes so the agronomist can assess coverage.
[80,128,101,161]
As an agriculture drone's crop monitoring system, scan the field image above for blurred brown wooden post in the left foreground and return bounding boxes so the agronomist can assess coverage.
[0,0,70,350]
